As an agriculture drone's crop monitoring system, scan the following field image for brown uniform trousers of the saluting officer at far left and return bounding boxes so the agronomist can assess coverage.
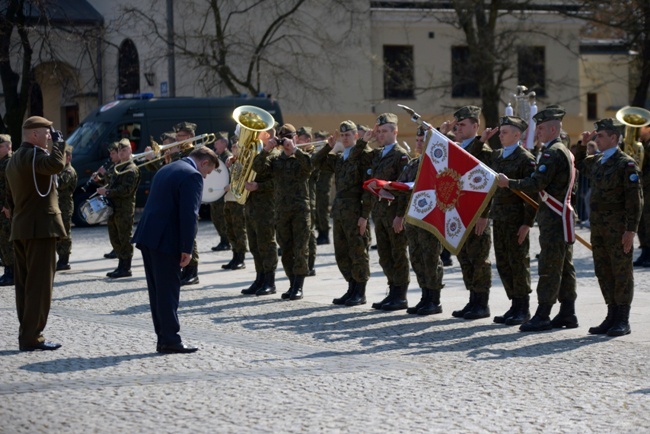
[13,238,56,347]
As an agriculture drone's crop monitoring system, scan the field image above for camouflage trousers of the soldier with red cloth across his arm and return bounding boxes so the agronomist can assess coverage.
[372,213,411,286]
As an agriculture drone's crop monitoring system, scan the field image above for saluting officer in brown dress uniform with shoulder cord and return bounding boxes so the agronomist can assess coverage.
[6,116,66,351]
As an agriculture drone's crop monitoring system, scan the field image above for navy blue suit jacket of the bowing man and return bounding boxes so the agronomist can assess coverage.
[132,158,203,258]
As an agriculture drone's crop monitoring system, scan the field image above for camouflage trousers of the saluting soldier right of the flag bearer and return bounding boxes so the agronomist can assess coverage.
[590,212,634,305]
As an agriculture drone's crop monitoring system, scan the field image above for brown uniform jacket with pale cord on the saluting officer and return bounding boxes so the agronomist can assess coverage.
[6,142,66,241]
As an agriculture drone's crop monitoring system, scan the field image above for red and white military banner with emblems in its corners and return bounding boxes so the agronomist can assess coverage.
[406,129,497,254]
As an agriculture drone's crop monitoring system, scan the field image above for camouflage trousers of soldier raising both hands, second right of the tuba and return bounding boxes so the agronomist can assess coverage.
[275,208,311,276]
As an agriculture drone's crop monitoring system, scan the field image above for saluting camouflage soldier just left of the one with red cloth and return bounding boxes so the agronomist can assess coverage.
[313,121,371,306]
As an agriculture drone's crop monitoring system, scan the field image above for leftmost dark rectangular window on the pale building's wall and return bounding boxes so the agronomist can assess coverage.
[384,45,415,99]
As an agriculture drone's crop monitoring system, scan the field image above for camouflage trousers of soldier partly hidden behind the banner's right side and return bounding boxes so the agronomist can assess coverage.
[457,225,492,294]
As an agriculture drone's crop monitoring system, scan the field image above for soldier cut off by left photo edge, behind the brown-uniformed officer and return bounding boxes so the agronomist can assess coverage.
[0,134,14,286]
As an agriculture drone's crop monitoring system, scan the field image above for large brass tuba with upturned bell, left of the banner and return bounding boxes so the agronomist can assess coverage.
[230,105,275,205]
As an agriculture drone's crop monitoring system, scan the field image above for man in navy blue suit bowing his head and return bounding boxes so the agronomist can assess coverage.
[133,146,219,353]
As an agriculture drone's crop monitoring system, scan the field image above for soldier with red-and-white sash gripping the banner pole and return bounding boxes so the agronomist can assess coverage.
[497,105,578,332]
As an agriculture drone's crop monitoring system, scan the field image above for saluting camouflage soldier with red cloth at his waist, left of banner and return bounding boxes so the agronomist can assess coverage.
[362,113,410,310]
